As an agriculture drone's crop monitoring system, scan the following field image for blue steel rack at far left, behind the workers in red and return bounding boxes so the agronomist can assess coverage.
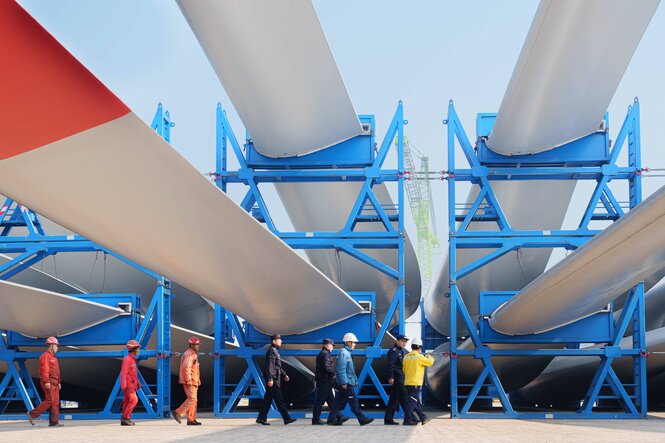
[0,103,174,420]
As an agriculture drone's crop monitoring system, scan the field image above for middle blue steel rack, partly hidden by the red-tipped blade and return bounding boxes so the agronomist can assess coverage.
[210,101,408,417]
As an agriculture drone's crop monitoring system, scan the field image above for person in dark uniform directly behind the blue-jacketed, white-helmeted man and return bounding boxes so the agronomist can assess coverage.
[312,338,342,426]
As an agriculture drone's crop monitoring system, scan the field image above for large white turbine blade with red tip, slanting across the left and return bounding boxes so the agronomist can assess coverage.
[0,2,361,334]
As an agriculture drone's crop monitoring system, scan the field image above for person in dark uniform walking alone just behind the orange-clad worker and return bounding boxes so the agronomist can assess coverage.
[256,334,296,425]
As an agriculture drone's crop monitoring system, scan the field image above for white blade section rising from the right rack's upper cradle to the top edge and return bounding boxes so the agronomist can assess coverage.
[488,0,660,155]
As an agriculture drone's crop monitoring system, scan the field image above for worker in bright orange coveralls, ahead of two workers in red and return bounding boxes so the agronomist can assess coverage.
[171,337,201,426]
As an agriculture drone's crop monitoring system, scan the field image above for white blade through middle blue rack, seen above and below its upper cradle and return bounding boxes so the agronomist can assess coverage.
[178,0,420,324]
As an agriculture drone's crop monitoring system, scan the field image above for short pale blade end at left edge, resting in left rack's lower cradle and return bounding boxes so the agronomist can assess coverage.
[0,280,124,338]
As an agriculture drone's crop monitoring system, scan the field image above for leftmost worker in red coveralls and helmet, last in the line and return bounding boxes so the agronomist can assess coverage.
[28,337,64,426]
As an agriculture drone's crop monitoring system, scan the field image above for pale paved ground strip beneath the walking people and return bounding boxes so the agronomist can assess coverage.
[0,413,665,443]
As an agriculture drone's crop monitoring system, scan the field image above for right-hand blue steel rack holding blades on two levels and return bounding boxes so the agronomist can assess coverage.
[444,99,647,418]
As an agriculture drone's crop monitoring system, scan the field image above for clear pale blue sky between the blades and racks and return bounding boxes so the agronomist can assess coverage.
[20,0,665,280]
